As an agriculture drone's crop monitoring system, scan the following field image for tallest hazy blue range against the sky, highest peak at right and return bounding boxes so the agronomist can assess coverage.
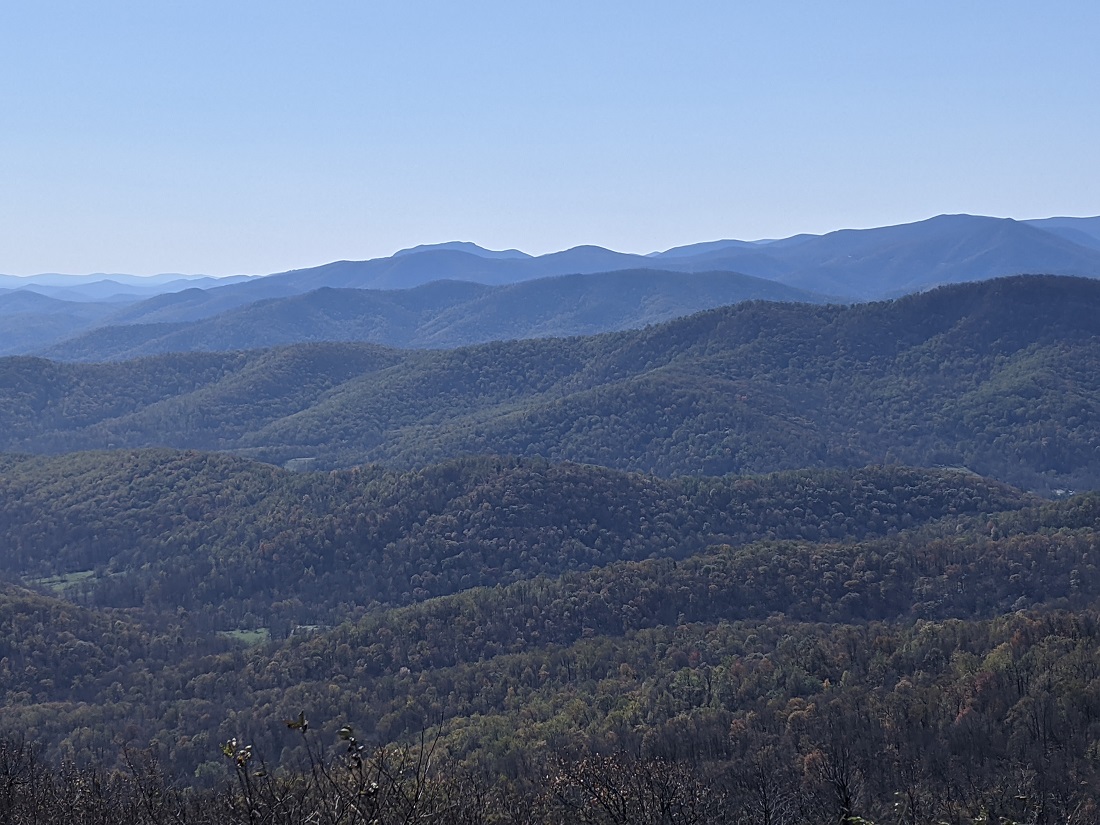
[251,215,1100,300]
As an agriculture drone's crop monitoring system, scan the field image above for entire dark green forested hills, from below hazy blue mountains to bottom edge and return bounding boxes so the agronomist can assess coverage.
[0,277,1100,825]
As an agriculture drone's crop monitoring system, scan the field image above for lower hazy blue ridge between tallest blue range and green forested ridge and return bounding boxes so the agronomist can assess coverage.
[32,270,824,362]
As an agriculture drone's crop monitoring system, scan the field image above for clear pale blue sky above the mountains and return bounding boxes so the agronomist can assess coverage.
[0,0,1100,275]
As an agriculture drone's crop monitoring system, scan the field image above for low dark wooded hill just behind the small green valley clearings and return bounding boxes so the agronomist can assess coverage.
[0,451,1030,635]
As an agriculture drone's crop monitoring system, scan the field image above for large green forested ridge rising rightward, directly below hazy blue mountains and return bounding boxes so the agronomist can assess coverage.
[0,277,1100,493]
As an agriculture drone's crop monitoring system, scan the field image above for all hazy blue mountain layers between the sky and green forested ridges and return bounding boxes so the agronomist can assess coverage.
[0,215,1100,361]
